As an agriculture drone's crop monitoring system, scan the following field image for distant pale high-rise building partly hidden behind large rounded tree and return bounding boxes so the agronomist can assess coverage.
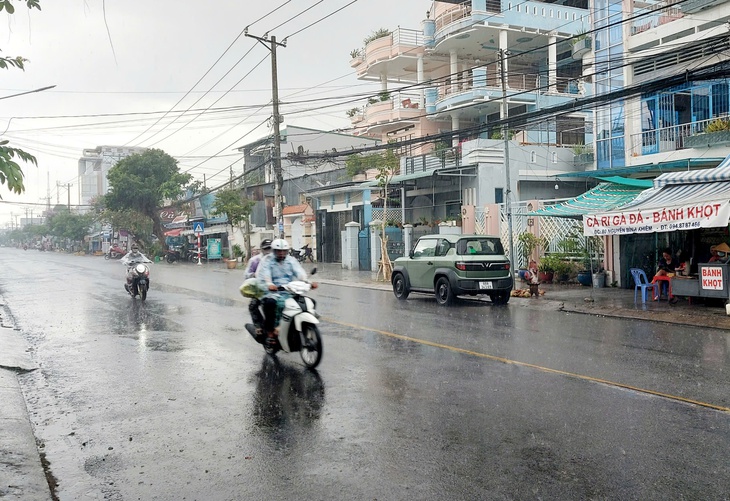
[79,146,145,205]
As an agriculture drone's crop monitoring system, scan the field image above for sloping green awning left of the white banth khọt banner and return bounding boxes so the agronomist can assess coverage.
[527,181,651,217]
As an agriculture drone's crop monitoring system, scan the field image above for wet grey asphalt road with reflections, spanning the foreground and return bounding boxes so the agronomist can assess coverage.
[0,248,730,500]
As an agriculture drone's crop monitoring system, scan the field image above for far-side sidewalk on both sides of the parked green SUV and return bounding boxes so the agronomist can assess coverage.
[306,263,730,329]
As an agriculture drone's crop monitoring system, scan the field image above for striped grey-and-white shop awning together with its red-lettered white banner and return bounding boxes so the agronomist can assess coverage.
[583,181,730,235]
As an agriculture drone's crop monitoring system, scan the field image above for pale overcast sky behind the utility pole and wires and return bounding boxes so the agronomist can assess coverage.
[0,0,431,223]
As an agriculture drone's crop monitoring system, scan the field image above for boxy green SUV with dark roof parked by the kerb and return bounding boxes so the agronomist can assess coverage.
[391,235,513,305]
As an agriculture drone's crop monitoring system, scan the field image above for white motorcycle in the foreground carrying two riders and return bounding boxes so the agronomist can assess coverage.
[242,269,323,369]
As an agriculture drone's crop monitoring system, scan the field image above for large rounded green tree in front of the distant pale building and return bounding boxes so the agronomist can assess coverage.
[103,149,192,242]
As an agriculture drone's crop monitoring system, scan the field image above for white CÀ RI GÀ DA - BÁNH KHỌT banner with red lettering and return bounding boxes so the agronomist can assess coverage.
[583,200,730,236]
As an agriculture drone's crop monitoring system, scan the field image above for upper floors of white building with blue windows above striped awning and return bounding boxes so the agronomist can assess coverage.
[620,0,730,170]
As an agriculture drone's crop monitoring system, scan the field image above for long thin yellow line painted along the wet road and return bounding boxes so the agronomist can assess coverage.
[323,318,730,412]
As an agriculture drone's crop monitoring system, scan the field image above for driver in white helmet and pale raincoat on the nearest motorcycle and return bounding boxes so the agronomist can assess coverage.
[256,238,317,343]
